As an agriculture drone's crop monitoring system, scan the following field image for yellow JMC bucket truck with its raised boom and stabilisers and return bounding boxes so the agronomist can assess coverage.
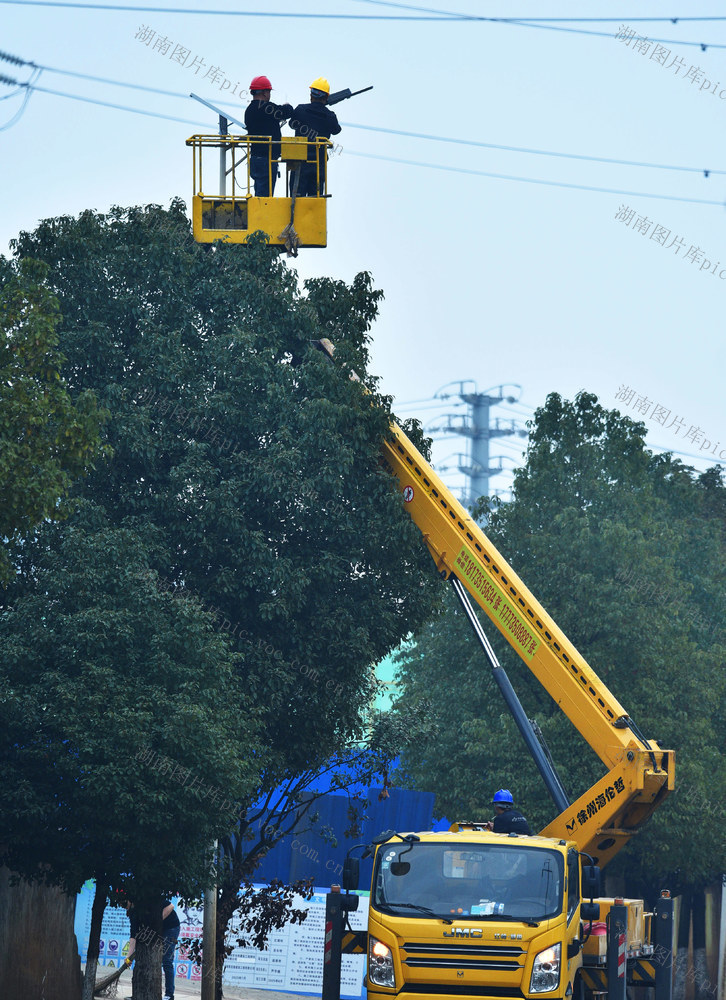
[318,341,675,1000]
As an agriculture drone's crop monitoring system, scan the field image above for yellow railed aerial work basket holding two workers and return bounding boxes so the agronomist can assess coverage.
[187,135,332,250]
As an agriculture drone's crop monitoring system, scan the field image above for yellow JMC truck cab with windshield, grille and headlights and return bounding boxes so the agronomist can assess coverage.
[366,825,582,1000]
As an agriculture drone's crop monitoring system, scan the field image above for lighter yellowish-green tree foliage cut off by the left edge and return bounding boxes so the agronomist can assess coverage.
[0,258,104,584]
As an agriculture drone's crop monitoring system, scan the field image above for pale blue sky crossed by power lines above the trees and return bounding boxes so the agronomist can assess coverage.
[0,0,726,500]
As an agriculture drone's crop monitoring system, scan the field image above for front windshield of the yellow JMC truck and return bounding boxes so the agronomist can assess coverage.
[373,841,564,921]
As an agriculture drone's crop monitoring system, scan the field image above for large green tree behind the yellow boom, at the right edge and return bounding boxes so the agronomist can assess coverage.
[398,393,726,894]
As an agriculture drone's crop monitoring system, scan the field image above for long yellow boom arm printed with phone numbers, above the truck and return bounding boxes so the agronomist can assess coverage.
[383,424,675,866]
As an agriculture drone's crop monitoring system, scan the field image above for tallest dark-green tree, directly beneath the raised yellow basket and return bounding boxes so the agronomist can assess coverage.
[1,202,434,1000]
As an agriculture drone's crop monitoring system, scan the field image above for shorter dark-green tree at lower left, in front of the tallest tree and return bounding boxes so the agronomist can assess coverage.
[0,503,260,997]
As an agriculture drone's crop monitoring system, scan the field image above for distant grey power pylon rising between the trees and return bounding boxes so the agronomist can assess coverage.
[432,379,527,506]
